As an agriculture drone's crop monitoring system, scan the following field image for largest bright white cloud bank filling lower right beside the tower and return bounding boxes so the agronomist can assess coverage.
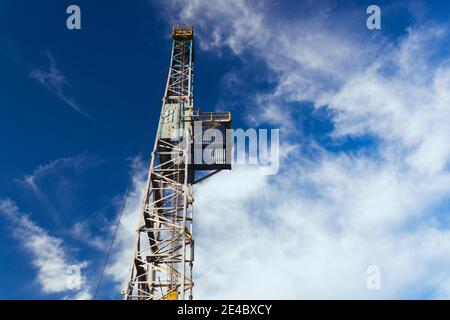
[194,156,450,299]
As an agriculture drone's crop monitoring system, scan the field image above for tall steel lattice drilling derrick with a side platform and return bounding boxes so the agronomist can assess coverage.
[122,26,231,300]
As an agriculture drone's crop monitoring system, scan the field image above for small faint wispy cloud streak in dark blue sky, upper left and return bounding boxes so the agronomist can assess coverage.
[30,51,91,119]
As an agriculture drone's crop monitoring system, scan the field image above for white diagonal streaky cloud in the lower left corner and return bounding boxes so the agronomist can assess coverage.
[0,199,89,298]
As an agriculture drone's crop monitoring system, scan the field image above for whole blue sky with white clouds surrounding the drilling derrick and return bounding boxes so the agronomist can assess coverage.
[0,0,450,299]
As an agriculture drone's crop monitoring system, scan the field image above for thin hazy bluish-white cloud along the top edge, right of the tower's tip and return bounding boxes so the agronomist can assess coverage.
[164,0,385,113]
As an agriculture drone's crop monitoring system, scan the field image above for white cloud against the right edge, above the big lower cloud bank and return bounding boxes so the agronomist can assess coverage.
[329,27,450,175]
